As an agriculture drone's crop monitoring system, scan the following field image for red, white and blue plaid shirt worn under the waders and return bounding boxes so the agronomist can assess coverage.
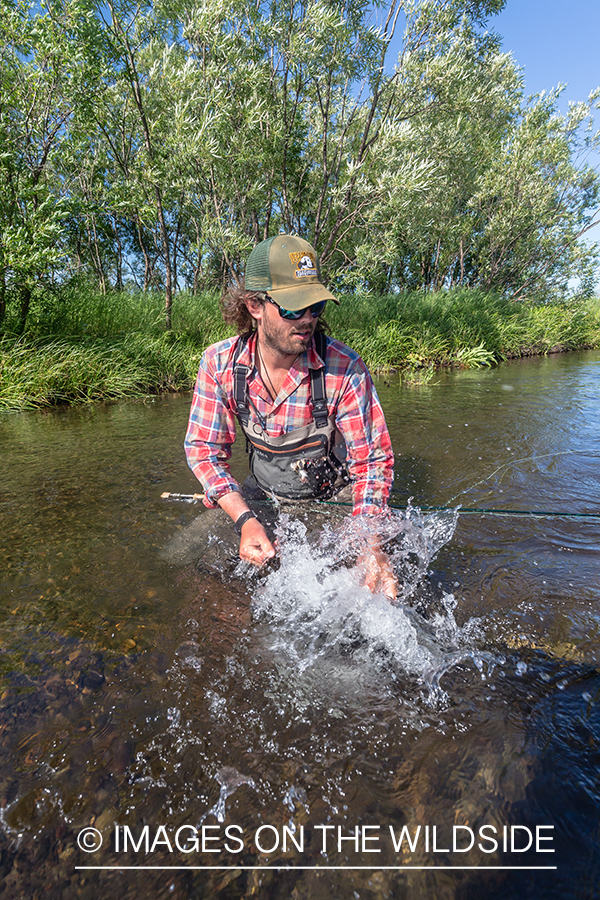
[185,333,394,515]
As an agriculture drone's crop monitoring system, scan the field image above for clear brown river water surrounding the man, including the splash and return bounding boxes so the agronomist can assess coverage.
[0,353,600,900]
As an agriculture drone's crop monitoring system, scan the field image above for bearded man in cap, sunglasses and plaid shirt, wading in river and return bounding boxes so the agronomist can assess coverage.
[185,234,397,598]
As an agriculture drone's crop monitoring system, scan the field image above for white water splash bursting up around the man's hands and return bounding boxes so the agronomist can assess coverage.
[248,507,493,699]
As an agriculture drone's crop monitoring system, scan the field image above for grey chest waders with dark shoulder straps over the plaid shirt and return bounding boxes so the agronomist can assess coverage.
[233,332,350,500]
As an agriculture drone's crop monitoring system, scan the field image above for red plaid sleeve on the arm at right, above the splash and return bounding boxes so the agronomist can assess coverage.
[336,359,394,516]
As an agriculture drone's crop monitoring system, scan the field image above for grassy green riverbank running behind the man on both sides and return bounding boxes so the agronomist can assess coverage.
[0,289,600,410]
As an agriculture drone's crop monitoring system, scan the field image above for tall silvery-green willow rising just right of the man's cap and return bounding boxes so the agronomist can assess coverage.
[346,37,521,291]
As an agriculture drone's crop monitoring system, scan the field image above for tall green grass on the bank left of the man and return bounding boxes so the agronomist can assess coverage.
[0,286,230,410]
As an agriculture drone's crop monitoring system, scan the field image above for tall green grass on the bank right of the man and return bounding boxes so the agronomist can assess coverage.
[327,289,600,369]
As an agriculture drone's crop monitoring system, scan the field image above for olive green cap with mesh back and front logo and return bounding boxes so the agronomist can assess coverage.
[245,234,340,311]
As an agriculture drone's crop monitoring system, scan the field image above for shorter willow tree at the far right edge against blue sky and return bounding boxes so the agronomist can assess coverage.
[471,89,600,298]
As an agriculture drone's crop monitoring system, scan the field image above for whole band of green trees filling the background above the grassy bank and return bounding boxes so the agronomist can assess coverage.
[0,0,600,334]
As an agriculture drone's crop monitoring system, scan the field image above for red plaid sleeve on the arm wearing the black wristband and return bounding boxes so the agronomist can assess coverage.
[185,348,240,508]
